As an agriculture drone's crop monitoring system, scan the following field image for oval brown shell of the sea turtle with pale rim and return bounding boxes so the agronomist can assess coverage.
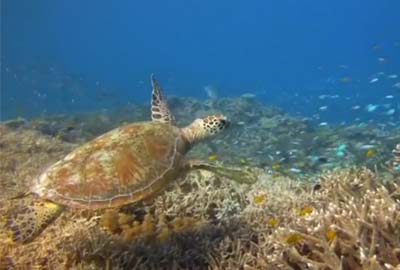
[33,122,186,209]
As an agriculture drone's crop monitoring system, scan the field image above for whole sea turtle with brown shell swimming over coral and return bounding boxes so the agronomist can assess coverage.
[6,75,254,243]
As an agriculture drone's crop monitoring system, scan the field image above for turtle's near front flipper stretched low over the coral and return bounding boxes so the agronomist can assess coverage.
[186,160,258,184]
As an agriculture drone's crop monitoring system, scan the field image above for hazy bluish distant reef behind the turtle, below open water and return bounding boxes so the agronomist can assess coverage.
[5,97,400,179]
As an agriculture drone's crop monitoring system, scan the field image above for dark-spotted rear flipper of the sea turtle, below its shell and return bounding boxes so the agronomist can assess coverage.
[6,200,63,243]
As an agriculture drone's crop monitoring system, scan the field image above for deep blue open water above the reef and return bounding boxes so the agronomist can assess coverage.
[1,0,400,122]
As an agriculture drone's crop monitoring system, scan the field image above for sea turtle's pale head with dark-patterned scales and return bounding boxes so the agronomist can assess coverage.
[182,114,229,144]
